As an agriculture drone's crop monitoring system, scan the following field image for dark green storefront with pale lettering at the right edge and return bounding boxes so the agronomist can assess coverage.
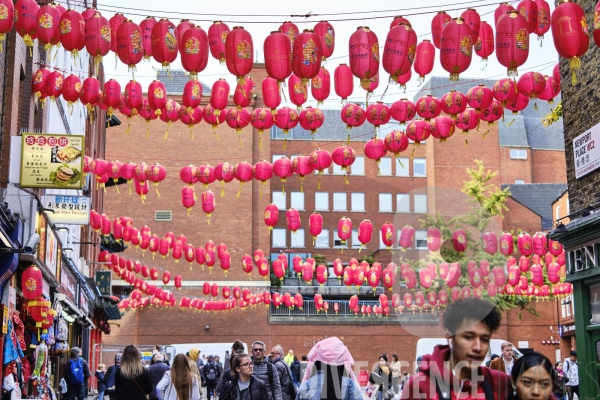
[549,216,600,399]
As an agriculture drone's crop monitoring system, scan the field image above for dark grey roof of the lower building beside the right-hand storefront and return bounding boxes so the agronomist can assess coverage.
[502,183,567,230]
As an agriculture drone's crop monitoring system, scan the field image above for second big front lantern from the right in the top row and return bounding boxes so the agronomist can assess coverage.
[496,11,529,76]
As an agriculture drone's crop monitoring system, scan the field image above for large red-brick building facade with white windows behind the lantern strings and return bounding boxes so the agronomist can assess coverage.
[105,65,564,368]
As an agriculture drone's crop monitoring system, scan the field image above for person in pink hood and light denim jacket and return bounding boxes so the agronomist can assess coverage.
[296,337,363,400]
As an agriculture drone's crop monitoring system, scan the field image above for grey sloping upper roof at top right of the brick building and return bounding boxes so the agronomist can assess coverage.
[413,76,565,150]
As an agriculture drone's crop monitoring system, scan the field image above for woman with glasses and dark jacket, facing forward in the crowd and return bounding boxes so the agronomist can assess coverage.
[219,352,269,400]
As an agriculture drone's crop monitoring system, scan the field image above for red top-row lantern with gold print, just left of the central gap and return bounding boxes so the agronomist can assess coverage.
[225,26,254,81]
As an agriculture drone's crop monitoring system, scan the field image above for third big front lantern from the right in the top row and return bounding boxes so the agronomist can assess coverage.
[440,18,473,81]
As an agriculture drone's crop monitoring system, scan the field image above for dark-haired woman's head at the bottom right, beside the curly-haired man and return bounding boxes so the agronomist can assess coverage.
[510,351,554,400]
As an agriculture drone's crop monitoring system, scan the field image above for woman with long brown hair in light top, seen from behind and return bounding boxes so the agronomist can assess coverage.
[156,354,200,400]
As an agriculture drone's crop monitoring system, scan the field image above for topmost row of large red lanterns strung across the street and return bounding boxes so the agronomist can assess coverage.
[16,0,600,90]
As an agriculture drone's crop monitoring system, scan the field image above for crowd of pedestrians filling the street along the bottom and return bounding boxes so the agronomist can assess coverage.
[72,298,579,400]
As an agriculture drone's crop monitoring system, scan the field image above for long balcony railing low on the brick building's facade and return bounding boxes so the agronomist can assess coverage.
[270,300,437,322]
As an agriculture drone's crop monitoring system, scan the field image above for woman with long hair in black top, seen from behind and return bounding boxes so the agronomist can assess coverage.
[115,344,152,400]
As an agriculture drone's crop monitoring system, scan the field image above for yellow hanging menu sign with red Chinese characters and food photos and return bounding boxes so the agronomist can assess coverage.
[21,133,84,189]
